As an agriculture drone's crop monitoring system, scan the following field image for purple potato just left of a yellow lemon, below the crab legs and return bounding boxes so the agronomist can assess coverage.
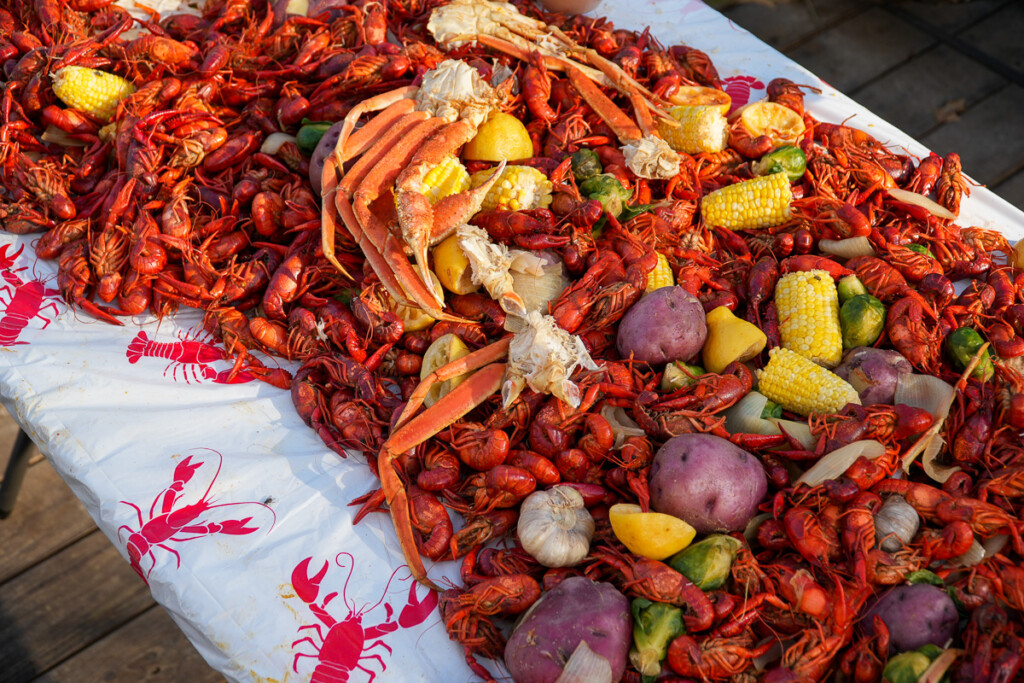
[615,286,708,364]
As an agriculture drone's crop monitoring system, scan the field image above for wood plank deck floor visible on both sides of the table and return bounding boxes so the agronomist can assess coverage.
[0,0,1024,683]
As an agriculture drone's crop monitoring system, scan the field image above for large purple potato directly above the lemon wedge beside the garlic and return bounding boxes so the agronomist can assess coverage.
[650,434,768,533]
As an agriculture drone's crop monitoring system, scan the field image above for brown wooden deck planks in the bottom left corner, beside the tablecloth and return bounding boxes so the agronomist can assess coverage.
[0,409,224,683]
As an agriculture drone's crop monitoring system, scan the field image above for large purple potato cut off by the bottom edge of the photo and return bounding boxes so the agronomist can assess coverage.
[505,577,633,683]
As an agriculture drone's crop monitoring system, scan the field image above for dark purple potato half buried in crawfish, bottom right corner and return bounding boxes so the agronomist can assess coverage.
[862,584,959,652]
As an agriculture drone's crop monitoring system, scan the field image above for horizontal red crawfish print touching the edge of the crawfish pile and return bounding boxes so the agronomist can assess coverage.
[125,328,264,384]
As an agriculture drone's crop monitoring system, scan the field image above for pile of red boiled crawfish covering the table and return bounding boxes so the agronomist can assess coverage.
[6,0,1024,681]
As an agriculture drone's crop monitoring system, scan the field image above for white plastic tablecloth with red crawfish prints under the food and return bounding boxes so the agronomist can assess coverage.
[0,0,1024,682]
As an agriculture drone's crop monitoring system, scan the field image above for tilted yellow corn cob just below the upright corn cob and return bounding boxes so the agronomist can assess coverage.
[758,347,860,415]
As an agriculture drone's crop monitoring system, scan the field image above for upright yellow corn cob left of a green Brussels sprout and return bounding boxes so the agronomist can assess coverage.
[775,270,843,368]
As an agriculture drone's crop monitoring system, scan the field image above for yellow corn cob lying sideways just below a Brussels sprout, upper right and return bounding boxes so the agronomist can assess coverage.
[700,173,793,230]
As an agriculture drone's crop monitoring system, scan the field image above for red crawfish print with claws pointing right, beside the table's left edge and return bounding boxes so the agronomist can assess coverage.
[118,449,276,584]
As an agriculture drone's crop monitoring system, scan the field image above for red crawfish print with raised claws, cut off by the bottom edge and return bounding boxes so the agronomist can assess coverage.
[292,552,437,683]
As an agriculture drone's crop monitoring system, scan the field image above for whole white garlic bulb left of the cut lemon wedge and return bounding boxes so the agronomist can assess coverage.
[516,486,594,567]
